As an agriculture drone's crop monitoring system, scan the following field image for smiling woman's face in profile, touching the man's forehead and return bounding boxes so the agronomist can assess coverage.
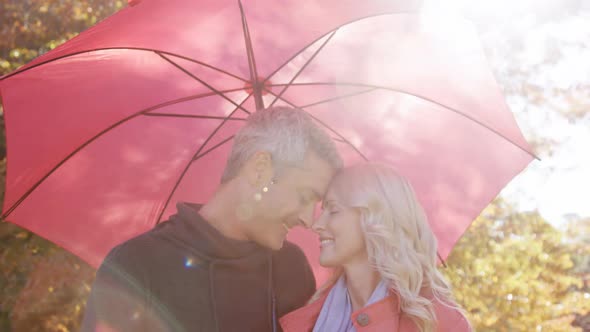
[312,187,368,267]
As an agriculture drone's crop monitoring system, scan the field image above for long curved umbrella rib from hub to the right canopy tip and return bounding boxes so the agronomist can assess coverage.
[268,82,541,160]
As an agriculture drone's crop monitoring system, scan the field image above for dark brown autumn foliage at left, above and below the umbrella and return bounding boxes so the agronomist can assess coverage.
[0,0,126,332]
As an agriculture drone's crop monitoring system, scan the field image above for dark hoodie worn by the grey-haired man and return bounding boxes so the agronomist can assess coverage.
[82,203,315,332]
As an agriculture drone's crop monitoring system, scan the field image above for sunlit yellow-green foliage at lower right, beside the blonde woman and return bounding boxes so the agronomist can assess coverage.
[444,199,590,332]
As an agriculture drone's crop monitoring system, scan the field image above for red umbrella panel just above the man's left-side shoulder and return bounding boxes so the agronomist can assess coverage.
[10,116,231,266]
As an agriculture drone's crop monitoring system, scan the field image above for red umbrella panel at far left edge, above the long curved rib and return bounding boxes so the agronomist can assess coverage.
[0,50,234,211]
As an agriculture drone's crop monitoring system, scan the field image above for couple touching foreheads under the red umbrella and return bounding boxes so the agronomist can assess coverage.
[82,107,470,332]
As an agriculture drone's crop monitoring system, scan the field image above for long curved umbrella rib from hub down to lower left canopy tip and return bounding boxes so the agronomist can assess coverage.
[2,88,243,219]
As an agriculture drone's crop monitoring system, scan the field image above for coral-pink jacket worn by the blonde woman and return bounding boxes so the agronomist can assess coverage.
[279,291,471,332]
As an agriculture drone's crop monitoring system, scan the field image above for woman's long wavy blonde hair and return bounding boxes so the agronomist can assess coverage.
[311,163,465,332]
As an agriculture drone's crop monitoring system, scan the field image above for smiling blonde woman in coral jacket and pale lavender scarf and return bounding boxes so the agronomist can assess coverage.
[280,164,471,332]
